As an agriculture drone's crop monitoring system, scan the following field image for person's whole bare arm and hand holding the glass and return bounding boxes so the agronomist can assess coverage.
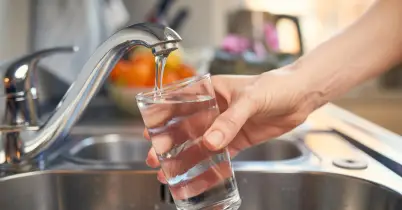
[144,0,402,182]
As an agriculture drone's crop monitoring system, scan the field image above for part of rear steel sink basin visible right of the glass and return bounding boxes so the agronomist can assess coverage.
[233,139,302,161]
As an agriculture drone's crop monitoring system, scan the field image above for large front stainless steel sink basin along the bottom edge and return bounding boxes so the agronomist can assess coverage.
[0,171,402,210]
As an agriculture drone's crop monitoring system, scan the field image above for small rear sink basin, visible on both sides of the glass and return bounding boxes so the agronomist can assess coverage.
[64,134,302,165]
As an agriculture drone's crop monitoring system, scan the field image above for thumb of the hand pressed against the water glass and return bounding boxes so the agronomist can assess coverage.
[203,97,253,151]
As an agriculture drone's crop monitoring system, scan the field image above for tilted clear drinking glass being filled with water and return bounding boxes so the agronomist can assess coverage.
[136,74,241,210]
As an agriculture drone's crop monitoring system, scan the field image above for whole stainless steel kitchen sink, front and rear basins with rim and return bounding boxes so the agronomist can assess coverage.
[4,101,402,210]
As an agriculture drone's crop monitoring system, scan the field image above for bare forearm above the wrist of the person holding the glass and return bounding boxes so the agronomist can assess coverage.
[292,0,402,106]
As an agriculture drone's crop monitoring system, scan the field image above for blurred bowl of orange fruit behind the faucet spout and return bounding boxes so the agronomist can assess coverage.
[105,47,197,117]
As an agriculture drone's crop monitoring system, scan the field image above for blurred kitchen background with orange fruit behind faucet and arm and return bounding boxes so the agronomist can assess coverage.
[0,0,402,134]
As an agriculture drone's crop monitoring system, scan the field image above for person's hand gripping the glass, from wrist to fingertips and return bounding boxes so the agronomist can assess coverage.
[144,68,323,180]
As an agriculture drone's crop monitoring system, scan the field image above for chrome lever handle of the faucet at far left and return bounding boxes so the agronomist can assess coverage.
[0,46,78,126]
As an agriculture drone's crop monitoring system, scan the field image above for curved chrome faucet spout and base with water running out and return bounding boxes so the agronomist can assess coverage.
[0,23,181,173]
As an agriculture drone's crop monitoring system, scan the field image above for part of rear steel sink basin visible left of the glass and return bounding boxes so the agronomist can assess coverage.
[66,134,151,164]
